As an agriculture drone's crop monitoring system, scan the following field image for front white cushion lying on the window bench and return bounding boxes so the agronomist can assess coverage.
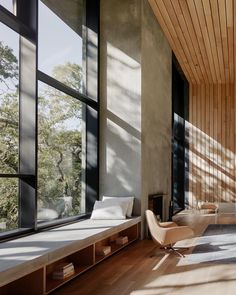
[90,200,129,219]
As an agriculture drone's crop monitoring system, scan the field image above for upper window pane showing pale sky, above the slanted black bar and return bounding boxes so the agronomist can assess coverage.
[38,0,83,92]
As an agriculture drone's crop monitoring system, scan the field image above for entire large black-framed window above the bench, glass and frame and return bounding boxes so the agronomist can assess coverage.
[0,0,99,238]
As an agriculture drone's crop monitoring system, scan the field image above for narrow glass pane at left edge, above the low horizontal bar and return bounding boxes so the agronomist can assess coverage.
[0,23,19,173]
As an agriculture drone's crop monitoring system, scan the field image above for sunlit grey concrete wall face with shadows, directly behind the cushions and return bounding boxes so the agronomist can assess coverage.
[100,0,141,214]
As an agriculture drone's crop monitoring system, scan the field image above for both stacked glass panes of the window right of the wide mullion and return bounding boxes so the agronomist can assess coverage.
[38,1,86,222]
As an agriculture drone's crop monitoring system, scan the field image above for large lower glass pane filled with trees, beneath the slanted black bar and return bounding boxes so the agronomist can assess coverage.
[38,82,84,221]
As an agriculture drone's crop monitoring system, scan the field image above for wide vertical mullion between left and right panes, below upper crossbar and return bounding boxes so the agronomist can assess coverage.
[19,36,37,228]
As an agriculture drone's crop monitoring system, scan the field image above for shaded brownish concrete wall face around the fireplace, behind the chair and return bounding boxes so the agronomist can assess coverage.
[141,1,172,219]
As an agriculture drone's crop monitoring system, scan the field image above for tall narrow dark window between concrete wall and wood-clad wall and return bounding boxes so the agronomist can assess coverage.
[170,59,188,214]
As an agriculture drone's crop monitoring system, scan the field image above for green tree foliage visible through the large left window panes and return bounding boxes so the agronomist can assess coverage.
[0,42,82,230]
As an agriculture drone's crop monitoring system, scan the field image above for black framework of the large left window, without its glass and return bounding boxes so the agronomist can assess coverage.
[0,0,100,241]
